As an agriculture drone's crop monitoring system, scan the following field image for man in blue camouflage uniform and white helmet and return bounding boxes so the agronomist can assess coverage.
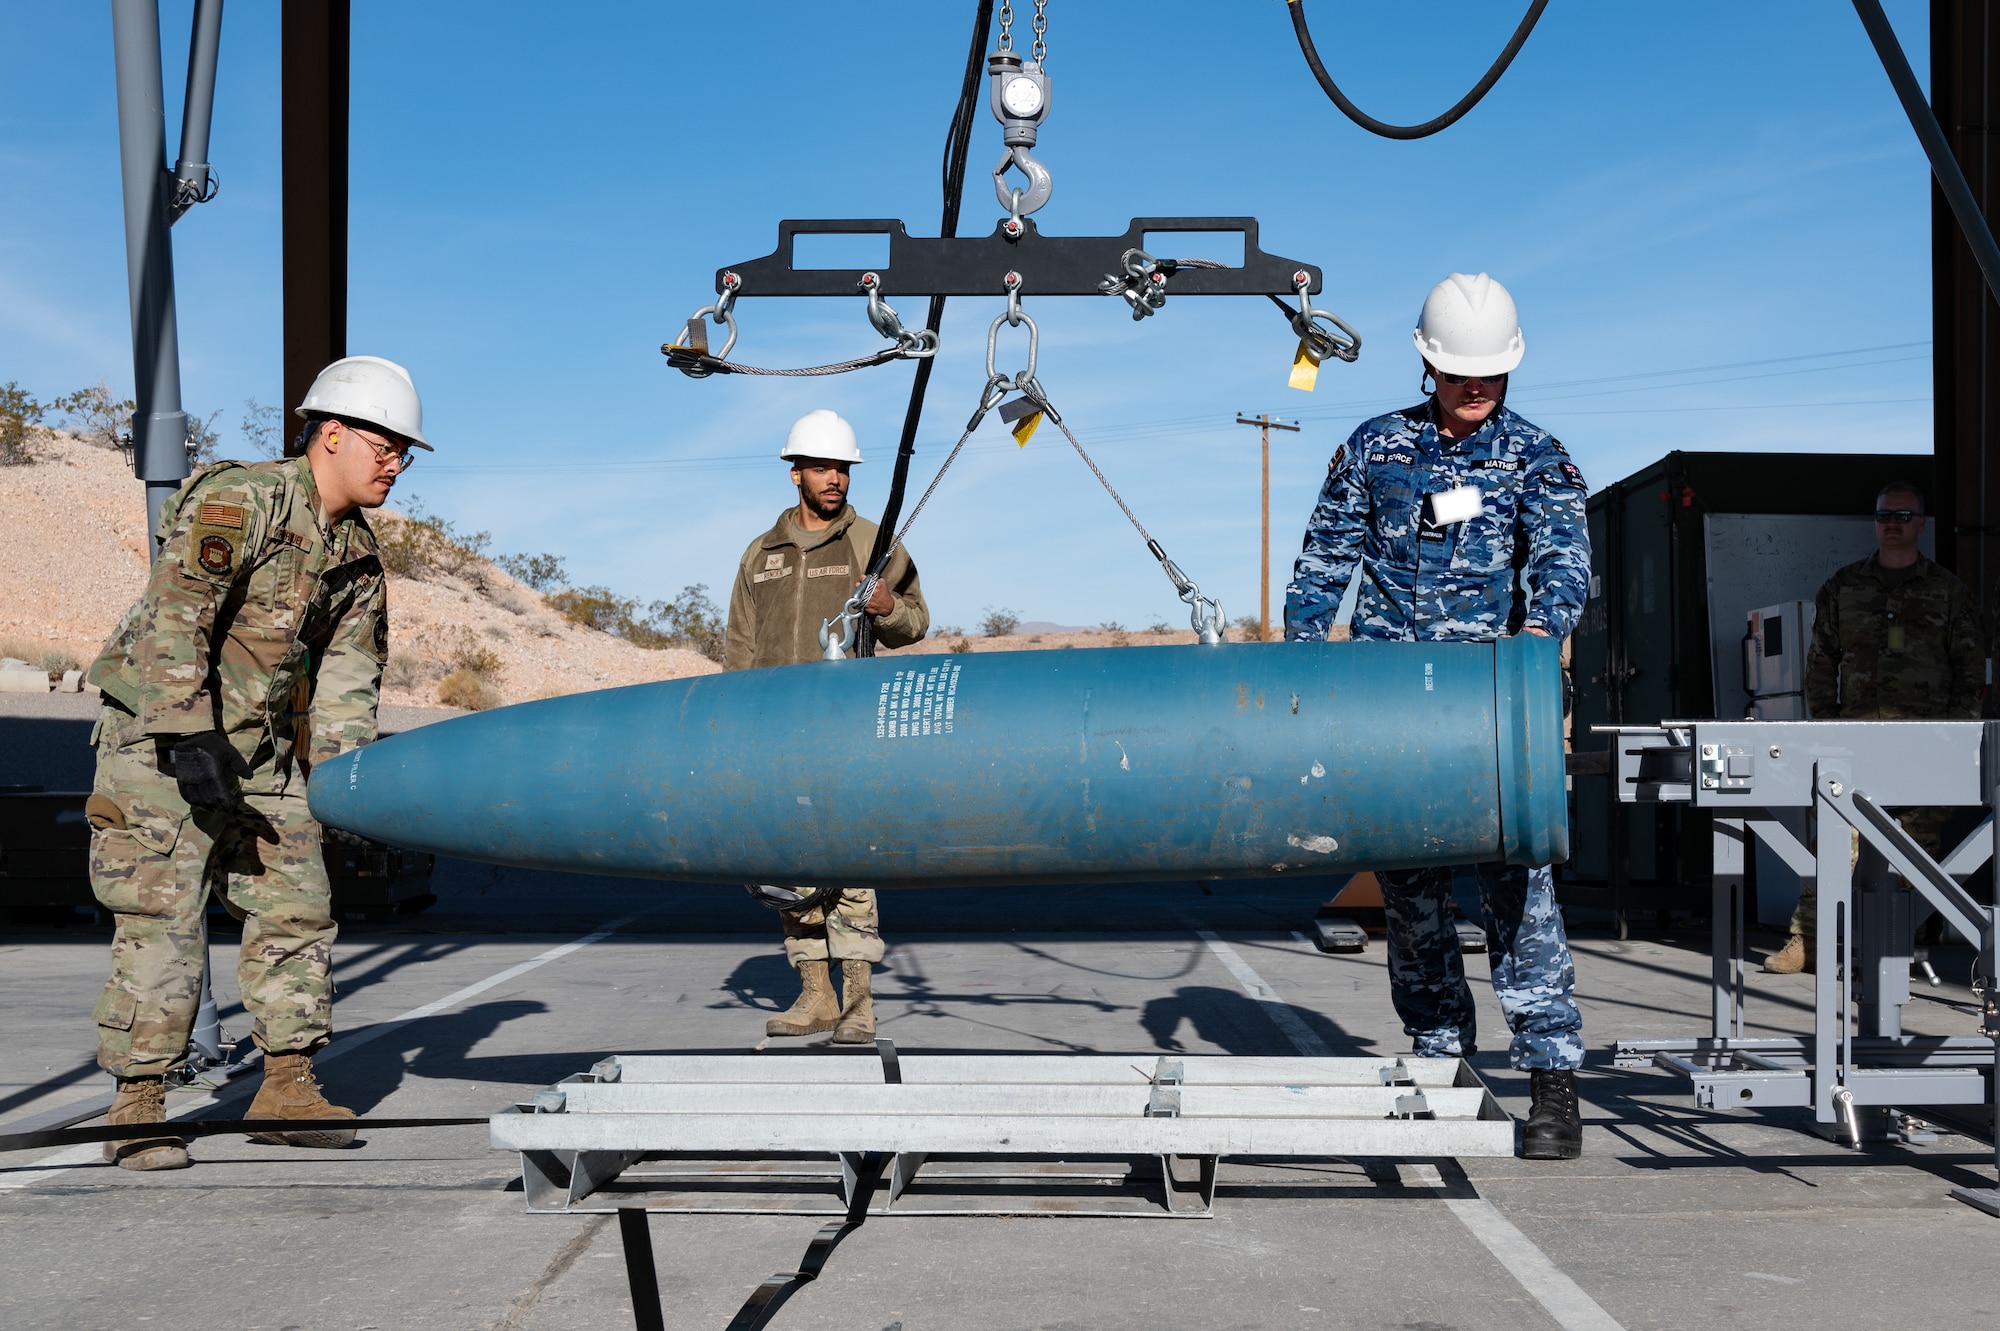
[1284,274,1590,1159]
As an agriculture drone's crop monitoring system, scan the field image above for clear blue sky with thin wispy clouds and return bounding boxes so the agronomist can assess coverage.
[0,0,1930,628]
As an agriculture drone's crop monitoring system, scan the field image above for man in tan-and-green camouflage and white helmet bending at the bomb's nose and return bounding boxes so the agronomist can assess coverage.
[86,356,430,1169]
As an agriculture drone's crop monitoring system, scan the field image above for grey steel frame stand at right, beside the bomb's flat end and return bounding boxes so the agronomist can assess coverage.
[1604,721,2000,1217]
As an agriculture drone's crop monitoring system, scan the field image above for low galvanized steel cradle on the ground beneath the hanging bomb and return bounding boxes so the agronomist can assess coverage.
[492,1039,1514,1217]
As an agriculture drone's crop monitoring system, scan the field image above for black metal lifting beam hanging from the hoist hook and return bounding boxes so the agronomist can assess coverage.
[716,218,1320,296]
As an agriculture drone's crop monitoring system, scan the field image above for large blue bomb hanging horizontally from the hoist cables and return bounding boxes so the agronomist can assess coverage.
[310,636,1568,887]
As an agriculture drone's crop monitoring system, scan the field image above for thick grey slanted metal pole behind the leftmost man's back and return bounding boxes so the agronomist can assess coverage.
[112,0,188,538]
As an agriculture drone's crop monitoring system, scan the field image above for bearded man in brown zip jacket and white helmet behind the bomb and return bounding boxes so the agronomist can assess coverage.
[724,408,930,1045]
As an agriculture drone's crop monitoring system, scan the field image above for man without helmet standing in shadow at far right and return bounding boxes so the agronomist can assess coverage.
[1764,482,1986,975]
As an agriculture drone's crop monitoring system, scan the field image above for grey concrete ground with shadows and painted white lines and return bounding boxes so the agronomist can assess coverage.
[0,911,2000,1331]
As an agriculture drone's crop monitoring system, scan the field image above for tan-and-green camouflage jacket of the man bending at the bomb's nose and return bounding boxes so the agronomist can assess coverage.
[88,458,388,795]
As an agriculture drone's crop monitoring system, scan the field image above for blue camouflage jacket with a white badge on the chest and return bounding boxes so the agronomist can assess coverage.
[1284,402,1590,642]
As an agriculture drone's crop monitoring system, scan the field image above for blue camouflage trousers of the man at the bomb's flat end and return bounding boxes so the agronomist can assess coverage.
[1376,863,1584,1071]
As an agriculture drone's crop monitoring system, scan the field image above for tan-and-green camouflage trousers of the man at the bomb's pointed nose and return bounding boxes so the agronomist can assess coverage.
[88,711,338,1077]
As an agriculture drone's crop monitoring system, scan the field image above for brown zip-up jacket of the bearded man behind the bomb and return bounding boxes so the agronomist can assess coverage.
[724,504,930,669]
